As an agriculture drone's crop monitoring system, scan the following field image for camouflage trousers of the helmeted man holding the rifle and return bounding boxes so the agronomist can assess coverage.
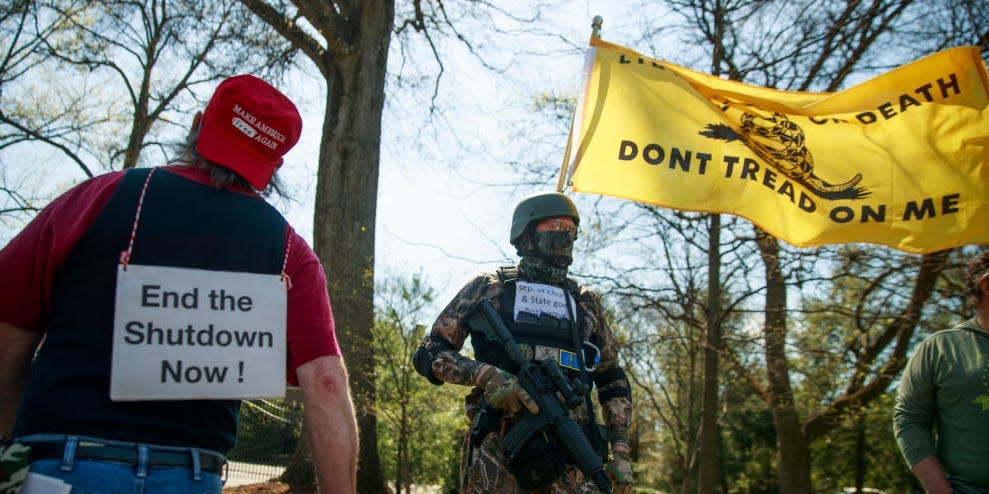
[460,432,601,494]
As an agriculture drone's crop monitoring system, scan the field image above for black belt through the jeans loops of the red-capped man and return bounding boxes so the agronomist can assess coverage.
[28,442,226,475]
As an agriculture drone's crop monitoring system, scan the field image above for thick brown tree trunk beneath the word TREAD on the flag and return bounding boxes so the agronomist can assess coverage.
[756,229,811,494]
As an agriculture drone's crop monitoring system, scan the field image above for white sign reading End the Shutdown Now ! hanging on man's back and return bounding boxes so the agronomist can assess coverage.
[110,264,287,401]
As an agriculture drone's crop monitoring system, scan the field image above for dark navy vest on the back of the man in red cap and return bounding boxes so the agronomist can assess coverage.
[14,169,287,453]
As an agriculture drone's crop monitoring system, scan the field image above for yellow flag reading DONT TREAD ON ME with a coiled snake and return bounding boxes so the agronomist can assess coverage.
[559,38,989,253]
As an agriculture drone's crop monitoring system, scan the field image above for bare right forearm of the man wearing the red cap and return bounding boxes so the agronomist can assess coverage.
[295,356,357,494]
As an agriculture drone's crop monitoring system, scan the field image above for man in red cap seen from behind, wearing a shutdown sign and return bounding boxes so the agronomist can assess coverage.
[0,75,357,494]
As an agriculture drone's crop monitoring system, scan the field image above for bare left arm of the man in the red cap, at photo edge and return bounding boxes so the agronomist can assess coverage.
[0,322,38,436]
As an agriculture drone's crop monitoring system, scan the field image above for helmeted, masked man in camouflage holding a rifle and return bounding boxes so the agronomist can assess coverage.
[413,193,632,494]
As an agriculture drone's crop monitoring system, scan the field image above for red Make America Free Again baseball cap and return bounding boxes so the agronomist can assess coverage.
[196,74,302,190]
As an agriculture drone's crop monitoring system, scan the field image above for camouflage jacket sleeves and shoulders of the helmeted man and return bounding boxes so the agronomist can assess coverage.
[420,272,632,449]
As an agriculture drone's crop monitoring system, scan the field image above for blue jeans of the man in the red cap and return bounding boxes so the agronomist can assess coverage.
[20,434,223,494]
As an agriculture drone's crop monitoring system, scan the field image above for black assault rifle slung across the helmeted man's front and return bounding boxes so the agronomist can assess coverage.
[468,300,611,494]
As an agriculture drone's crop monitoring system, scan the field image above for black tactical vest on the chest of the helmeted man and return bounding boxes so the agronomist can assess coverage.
[470,266,585,377]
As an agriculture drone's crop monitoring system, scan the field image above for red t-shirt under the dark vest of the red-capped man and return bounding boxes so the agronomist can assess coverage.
[0,165,340,385]
